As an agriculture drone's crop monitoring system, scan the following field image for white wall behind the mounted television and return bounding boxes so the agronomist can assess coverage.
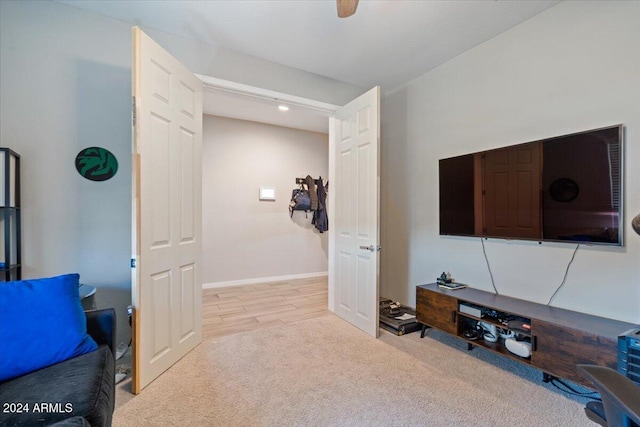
[381,1,640,323]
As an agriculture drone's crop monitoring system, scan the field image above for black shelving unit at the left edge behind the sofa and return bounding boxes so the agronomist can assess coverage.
[0,147,22,282]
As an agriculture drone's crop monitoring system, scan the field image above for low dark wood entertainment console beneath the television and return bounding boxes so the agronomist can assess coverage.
[416,283,637,387]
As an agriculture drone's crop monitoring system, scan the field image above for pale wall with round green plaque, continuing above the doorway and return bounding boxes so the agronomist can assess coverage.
[0,1,363,341]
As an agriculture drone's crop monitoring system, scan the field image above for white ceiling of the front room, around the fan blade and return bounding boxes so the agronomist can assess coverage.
[57,0,559,132]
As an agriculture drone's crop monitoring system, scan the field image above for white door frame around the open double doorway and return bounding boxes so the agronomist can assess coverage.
[194,73,341,312]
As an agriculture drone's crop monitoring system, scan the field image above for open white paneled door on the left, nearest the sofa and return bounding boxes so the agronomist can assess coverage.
[132,27,202,393]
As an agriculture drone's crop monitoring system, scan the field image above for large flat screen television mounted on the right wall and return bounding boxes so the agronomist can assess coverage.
[439,125,624,246]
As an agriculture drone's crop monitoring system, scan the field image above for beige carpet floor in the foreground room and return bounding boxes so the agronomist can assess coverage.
[113,314,593,427]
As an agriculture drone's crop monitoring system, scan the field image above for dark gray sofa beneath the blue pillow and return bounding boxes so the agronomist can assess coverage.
[0,308,116,427]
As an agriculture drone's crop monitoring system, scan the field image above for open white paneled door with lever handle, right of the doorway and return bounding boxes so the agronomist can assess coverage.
[329,87,380,337]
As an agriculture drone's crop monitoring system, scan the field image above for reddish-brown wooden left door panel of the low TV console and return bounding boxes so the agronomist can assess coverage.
[416,288,458,335]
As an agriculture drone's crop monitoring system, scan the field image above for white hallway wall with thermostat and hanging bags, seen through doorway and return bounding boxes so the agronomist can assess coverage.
[202,116,329,285]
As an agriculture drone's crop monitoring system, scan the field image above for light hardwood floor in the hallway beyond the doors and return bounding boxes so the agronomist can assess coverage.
[202,276,329,340]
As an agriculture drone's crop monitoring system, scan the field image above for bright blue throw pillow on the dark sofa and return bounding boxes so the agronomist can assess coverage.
[0,274,98,382]
